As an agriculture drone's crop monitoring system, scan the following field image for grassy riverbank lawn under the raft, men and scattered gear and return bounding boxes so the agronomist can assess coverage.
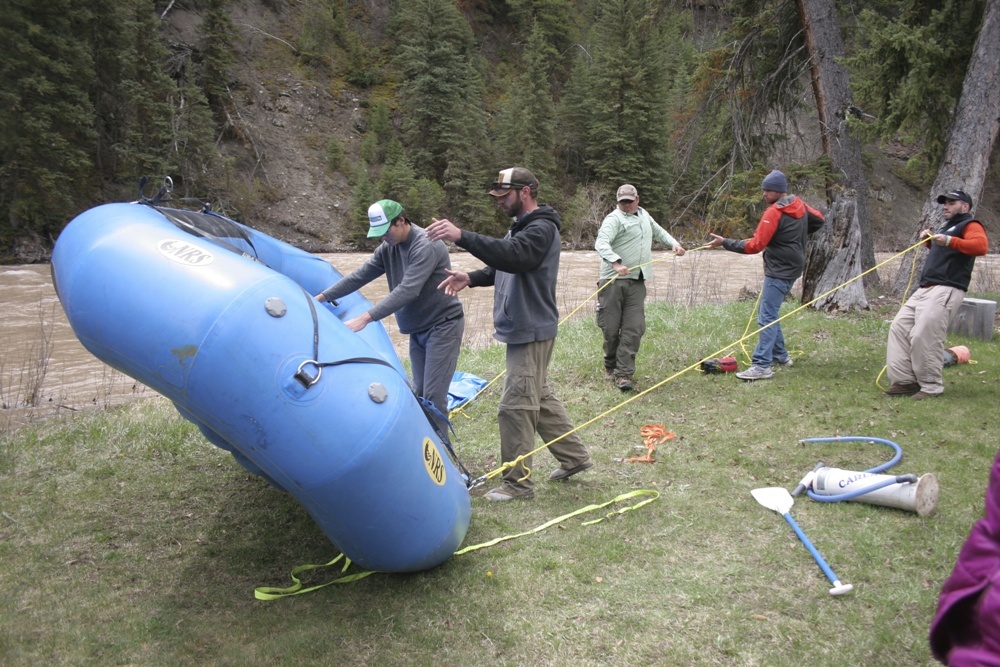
[0,295,1000,666]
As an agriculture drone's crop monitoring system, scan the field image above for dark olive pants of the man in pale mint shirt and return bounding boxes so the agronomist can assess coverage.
[597,278,646,377]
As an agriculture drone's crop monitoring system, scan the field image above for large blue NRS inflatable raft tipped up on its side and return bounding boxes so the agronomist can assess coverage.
[52,203,471,572]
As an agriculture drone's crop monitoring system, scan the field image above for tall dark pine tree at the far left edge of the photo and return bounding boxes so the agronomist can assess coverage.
[0,0,95,246]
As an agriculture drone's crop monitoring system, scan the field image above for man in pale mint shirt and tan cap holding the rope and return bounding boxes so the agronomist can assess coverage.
[594,183,684,391]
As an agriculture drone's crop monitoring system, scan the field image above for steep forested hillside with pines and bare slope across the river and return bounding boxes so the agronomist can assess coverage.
[0,0,996,261]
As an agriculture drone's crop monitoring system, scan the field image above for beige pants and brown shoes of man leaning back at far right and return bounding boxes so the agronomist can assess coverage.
[885,285,965,395]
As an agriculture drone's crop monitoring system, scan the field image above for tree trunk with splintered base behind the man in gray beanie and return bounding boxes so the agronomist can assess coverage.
[796,0,878,310]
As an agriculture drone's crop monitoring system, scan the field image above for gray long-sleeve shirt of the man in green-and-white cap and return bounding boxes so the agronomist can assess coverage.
[323,224,463,334]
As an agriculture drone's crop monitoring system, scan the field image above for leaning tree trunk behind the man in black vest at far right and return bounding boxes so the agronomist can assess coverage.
[892,0,1000,299]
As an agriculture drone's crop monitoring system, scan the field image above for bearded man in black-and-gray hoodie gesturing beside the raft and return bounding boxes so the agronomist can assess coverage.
[427,167,593,501]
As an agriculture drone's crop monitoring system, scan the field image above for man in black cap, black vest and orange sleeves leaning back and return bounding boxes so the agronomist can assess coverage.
[885,190,989,401]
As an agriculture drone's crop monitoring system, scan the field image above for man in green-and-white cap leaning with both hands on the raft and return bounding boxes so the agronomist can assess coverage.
[316,199,465,441]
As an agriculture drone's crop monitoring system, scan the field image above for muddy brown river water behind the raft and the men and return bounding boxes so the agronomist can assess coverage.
[0,251,978,431]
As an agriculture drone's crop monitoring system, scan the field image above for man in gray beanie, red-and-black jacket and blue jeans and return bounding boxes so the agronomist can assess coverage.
[708,169,825,381]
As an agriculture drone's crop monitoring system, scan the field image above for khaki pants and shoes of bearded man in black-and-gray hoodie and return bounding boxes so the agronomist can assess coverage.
[498,338,590,494]
